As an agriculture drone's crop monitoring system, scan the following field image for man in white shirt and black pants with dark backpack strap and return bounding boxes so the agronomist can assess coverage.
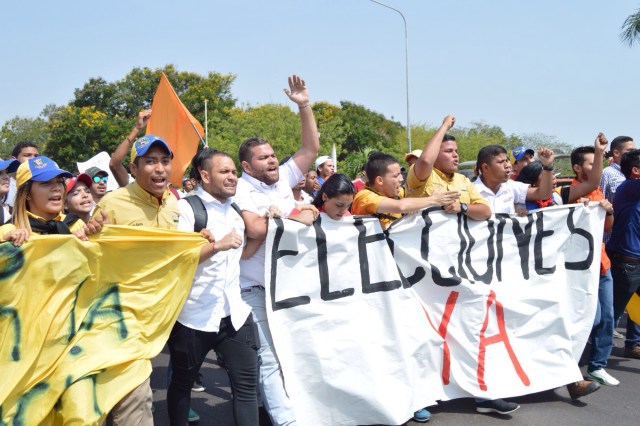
[167,148,258,426]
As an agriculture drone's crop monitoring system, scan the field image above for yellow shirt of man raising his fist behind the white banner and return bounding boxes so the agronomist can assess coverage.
[406,166,489,206]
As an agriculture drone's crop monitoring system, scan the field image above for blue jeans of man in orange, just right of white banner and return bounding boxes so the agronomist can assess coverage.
[588,269,614,371]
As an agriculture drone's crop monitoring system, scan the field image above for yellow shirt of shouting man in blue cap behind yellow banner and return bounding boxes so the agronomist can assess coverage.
[98,181,180,229]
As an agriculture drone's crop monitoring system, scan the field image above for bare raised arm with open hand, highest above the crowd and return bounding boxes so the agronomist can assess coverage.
[284,75,320,173]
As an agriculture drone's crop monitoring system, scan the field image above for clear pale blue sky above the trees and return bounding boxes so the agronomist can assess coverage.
[0,0,640,148]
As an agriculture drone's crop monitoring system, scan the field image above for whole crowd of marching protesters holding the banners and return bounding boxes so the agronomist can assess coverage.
[0,75,640,425]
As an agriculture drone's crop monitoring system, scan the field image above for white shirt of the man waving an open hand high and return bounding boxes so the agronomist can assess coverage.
[233,161,303,288]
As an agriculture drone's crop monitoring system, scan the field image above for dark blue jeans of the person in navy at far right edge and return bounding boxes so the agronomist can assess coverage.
[609,256,640,348]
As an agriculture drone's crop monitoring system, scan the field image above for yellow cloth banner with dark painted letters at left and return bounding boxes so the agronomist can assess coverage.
[0,226,205,425]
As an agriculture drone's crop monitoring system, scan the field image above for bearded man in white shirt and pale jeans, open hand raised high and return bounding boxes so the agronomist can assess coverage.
[235,75,320,425]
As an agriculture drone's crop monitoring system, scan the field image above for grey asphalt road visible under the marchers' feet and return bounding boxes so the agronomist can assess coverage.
[151,329,640,426]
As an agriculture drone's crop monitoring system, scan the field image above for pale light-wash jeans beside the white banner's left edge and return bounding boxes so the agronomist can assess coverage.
[242,287,296,426]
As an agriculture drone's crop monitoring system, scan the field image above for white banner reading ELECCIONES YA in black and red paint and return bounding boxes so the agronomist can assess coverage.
[265,205,604,425]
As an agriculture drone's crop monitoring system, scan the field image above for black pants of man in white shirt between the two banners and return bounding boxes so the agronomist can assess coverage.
[167,315,260,426]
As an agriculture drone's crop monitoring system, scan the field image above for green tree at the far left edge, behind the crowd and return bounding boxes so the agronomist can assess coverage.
[0,116,49,160]
